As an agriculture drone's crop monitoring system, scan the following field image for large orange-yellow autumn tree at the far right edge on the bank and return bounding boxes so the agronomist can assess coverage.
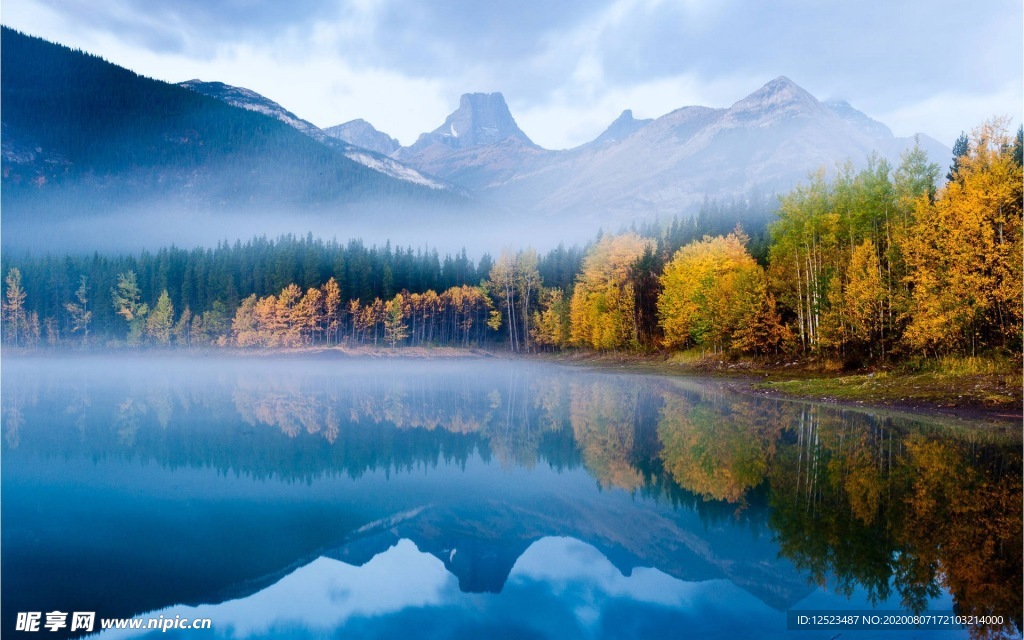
[903,119,1024,354]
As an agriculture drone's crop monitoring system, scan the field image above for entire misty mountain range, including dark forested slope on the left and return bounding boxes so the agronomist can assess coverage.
[0,28,950,246]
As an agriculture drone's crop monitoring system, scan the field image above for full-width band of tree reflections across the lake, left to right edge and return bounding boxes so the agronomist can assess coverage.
[3,356,1024,637]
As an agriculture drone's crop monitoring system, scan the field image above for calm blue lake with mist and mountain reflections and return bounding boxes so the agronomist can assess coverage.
[0,354,1022,640]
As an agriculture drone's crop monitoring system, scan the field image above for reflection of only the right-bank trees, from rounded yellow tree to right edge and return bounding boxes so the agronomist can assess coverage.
[658,394,1024,637]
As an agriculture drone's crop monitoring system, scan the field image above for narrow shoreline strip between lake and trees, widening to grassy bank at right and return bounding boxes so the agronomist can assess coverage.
[6,345,1024,428]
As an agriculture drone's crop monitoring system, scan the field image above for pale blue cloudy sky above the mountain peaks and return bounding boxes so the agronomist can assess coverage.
[0,0,1024,148]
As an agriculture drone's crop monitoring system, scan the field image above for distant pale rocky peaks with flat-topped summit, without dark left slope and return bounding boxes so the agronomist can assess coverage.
[385,77,949,222]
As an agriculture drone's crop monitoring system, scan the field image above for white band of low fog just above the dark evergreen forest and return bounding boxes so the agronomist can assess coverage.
[0,200,617,257]
